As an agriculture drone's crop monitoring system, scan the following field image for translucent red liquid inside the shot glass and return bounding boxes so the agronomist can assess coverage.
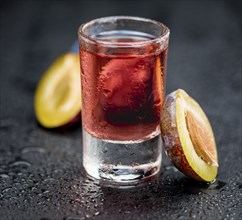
[80,39,167,141]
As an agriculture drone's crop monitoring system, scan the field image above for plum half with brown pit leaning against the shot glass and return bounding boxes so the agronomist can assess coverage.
[161,89,218,182]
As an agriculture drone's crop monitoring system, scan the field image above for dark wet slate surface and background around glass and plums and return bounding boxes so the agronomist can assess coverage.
[0,1,242,220]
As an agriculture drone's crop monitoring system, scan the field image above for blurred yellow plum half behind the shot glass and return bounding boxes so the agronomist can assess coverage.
[34,53,82,128]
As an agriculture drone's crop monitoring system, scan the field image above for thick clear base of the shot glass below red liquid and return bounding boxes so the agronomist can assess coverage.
[83,129,161,185]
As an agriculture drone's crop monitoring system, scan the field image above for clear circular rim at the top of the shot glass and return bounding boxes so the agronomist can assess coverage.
[78,16,170,48]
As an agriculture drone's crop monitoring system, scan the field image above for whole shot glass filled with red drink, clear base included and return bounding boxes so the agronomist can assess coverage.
[78,16,169,185]
